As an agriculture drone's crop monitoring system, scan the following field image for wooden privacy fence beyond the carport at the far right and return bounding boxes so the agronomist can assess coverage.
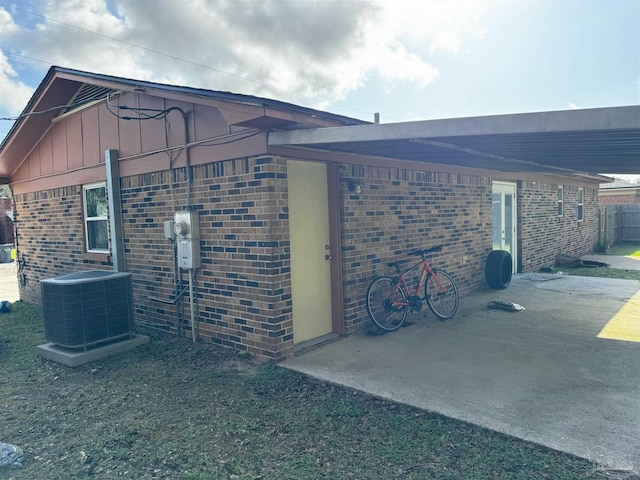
[598,203,640,246]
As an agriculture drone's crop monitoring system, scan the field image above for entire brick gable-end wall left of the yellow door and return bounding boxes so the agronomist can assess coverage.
[17,157,293,361]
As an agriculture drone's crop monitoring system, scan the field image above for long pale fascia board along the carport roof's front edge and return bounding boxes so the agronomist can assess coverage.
[269,106,640,145]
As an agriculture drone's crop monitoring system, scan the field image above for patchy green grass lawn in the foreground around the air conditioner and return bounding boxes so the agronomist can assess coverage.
[0,302,611,480]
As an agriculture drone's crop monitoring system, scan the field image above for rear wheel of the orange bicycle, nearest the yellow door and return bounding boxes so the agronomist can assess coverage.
[366,277,409,332]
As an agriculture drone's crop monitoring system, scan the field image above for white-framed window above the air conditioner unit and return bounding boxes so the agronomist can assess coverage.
[82,182,109,253]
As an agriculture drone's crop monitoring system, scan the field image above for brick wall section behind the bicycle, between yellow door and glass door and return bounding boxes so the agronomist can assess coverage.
[340,165,491,332]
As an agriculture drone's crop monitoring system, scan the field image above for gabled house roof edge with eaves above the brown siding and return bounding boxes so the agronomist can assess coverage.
[0,66,367,183]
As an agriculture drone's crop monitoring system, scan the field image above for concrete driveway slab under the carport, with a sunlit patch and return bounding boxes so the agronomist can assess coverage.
[280,272,640,472]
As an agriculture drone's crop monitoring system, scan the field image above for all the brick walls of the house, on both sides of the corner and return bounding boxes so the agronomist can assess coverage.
[16,156,597,361]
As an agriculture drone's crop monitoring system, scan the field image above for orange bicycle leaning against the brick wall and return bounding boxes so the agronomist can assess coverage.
[366,245,460,332]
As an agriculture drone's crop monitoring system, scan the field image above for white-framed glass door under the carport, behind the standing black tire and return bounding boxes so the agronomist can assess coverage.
[491,182,518,273]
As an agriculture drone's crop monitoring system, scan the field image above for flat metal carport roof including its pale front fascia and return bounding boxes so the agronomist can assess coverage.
[269,105,640,175]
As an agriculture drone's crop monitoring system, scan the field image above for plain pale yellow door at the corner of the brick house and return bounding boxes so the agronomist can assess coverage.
[287,160,332,344]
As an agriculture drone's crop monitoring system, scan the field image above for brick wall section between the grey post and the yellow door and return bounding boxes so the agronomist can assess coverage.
[122,157,293,361]
